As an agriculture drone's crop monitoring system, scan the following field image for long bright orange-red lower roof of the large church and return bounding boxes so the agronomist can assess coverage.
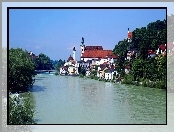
[81,50,118,59]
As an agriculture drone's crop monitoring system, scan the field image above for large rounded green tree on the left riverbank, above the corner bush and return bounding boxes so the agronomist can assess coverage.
[8,48,35,91]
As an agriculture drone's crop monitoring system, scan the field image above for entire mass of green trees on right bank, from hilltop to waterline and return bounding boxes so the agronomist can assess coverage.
[113,18,167,88]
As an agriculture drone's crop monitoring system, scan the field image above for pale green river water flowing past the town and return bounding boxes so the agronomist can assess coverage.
[25,74,166,124]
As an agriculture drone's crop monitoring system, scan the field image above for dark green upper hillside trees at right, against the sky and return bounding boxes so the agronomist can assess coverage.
[113,20,167,60]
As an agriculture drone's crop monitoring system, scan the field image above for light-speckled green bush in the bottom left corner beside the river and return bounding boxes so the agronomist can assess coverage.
[9,92,36,124]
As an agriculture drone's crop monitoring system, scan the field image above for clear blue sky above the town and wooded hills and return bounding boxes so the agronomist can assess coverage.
[9,9,166,60]
